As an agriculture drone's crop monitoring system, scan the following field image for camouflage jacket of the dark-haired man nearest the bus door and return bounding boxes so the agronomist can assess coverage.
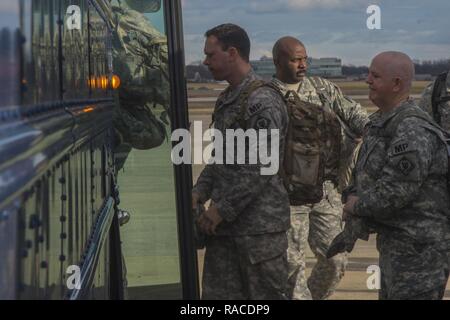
[194,71,290,235]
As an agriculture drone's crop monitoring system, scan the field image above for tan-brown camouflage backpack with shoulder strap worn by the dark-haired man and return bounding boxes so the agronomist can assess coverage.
[237,80,341,205]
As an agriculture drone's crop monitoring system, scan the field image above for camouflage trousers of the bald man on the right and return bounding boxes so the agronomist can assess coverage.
[377,233,449,300]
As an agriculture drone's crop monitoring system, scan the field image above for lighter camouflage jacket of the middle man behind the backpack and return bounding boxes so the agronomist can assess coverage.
[272,77,369,190]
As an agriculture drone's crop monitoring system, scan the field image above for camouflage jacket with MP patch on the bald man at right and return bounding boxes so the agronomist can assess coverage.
[354,100,450,242]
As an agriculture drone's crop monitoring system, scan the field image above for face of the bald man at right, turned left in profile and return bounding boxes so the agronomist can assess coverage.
[366,56,395,107]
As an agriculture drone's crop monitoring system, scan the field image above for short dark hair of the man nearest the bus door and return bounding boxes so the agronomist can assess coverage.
[205,23,250,62]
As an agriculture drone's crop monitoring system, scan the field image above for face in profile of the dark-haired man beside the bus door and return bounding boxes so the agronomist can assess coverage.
[203,36,230,81]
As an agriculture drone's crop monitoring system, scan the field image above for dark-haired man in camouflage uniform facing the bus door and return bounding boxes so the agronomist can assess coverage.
[192,24,289,300]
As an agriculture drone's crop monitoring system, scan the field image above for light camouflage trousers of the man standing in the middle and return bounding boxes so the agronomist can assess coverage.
[288,181,347,300]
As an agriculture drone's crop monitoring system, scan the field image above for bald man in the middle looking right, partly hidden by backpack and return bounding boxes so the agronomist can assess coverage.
[272,37,368,300]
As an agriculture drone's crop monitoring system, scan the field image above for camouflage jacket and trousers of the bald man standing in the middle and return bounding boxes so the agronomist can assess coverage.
[272,77,368,300]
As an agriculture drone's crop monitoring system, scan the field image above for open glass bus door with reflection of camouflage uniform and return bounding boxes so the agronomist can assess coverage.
[108,0,198,299]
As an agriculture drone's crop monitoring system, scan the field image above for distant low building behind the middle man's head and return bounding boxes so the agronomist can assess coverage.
[250,56,342,80]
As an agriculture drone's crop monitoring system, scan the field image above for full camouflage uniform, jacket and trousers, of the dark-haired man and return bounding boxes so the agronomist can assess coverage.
[194,71,289,299]
